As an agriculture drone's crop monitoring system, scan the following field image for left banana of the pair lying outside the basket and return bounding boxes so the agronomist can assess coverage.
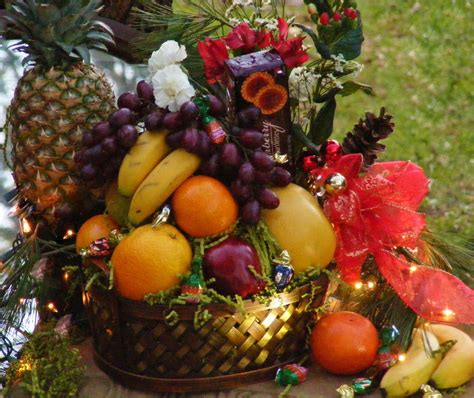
[380,329,441,397]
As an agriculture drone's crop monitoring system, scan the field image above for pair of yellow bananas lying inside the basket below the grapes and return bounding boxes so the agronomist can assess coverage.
[118,130,201,225]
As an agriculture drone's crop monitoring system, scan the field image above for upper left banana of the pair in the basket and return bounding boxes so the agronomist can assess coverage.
[118,130,171,197]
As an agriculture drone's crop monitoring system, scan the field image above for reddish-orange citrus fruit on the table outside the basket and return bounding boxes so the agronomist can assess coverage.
[311,311,379,375]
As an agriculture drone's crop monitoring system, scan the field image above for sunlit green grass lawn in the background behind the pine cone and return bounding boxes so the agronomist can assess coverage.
[291,0,474,240]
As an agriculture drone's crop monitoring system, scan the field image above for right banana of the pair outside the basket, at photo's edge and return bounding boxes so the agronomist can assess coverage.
[430,325,474,389]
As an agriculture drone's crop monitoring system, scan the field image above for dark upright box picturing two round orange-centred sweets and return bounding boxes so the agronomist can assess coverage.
[223,51,293,165]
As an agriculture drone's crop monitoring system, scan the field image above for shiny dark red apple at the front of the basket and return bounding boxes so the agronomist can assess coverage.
[203,237,265,298]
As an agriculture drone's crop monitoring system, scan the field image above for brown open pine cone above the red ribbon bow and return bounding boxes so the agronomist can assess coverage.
[342,108,395,169]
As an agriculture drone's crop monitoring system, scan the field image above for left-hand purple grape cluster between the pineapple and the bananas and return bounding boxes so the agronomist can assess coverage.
[74,80,156,188]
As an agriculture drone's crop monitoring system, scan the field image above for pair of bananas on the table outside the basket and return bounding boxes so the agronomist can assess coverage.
[380,325,474,397]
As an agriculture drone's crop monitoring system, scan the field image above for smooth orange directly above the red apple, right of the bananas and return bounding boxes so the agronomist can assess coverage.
[171,176,239,238]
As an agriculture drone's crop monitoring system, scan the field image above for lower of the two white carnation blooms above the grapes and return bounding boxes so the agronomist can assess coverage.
[152,65,196,112]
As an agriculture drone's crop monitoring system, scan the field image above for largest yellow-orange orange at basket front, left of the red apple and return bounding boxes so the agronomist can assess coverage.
[111,224,193,300]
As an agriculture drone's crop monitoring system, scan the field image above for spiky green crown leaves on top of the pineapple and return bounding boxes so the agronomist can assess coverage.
[5,0,114,68]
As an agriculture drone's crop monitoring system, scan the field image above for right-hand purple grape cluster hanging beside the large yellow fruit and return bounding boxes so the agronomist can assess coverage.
[201,106,292,224]
